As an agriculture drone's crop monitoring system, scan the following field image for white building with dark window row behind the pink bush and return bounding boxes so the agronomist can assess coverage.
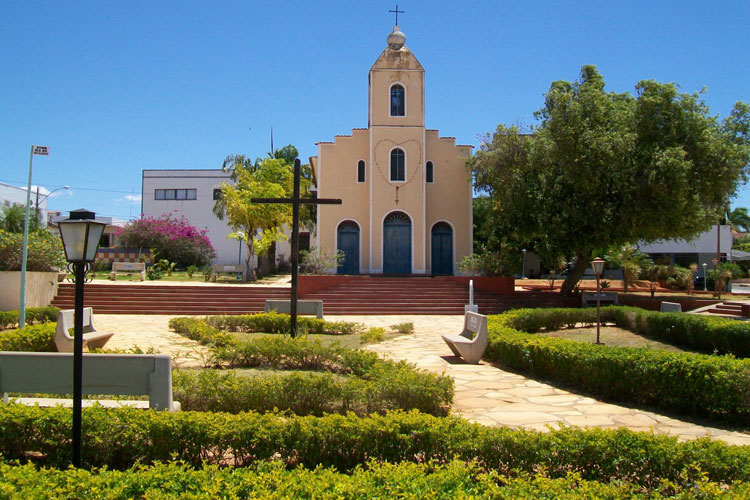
[141,169,247,264]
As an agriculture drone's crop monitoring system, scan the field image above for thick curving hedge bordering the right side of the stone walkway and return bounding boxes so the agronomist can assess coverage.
[484,308,750,425]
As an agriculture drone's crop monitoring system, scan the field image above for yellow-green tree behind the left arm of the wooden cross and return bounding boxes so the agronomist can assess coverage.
[214,155,294,280]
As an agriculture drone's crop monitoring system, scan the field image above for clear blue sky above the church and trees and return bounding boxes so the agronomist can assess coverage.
[0,0,750,219]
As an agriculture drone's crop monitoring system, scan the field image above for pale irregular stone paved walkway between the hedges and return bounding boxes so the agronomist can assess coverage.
[95,314,750,445]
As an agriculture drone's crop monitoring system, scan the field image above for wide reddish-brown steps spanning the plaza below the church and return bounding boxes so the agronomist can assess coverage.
[52,277,562,315]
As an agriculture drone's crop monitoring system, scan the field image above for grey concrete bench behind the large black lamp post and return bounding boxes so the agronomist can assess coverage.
[0,351,180,411]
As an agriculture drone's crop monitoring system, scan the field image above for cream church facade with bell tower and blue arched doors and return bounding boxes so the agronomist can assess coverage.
[310,26,473,275]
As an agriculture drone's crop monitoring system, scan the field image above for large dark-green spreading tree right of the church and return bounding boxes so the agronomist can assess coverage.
[469,66,750,294]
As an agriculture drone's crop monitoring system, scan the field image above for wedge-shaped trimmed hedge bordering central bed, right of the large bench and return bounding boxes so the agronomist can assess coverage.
[170,318,453,415]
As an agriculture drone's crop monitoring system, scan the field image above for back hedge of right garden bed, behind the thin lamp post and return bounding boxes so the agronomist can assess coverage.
[511,306,750,358]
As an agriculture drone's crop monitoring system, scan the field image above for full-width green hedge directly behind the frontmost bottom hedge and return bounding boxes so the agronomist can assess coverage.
[0,404,750,488]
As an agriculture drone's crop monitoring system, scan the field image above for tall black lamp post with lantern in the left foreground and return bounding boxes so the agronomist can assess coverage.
[59,208,106,467]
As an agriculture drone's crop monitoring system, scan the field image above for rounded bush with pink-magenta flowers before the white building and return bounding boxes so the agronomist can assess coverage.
[115,214,216,267]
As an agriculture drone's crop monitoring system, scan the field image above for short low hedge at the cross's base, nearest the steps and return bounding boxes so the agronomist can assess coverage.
[205,312,364,335]
